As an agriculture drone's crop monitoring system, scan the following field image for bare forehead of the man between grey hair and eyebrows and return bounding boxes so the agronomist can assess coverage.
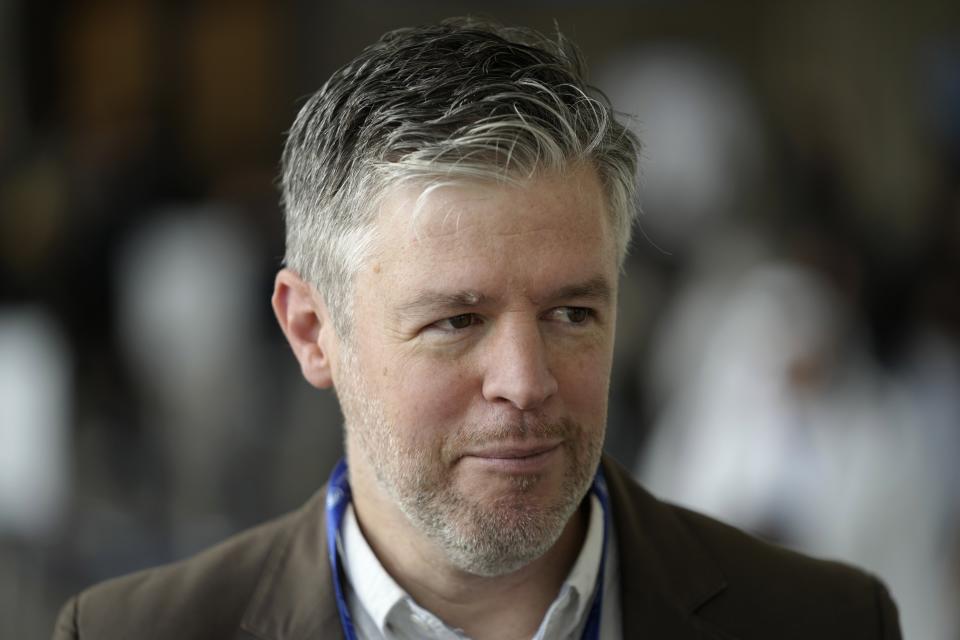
[357,168,617,301]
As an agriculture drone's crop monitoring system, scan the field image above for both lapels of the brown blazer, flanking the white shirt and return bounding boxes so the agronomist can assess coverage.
[237,457,734,640]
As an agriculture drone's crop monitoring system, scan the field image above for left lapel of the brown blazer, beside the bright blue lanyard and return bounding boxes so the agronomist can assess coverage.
[237,486,343,640]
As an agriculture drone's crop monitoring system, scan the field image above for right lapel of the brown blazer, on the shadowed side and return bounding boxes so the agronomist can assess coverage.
[603,457,733,640]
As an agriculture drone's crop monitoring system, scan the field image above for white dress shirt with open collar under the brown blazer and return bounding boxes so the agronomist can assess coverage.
[338,494,621,640]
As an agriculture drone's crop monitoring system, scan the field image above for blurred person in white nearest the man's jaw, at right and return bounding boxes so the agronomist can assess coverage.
[638,263,841,536]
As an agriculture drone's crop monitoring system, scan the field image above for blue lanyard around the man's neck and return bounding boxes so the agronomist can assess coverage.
[326,459,610,640]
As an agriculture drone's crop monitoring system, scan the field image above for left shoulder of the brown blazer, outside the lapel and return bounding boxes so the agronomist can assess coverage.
[54,504,300,640]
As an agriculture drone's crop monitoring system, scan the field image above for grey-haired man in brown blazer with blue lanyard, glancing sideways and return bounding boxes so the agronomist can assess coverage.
[56,21,899,640]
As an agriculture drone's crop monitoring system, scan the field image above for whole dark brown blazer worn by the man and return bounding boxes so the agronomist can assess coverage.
[53,459,900,640]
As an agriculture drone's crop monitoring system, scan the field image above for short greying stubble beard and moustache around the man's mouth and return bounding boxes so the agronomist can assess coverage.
[337,352,603,577]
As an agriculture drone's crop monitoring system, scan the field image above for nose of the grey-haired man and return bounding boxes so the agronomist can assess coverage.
[483,319,558,411]
